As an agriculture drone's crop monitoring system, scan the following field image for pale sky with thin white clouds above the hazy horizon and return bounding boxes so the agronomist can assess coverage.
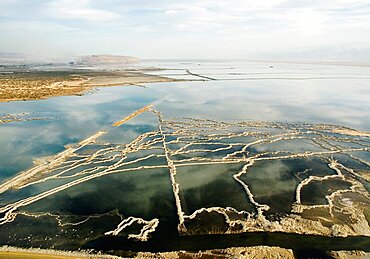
[0,0,370,61]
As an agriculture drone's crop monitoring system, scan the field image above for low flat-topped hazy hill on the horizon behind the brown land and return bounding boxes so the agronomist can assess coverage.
[75,55,139,65]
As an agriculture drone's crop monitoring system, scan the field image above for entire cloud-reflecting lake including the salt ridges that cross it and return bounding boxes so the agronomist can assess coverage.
[0,62,370,256]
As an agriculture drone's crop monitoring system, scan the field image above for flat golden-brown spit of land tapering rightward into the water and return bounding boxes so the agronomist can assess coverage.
[0,69,184,102]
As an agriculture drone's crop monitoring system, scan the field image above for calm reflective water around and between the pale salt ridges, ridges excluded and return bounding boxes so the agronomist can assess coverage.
[0,61,370,256]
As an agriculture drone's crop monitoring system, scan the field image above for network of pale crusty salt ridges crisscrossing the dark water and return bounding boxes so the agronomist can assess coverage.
[0,115,370,241]
